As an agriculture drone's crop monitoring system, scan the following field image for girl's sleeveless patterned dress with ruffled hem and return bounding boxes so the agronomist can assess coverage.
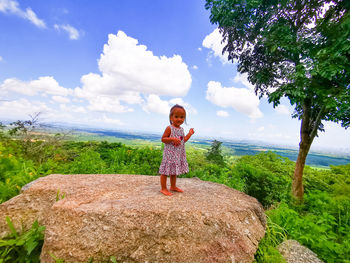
[159,125,188,176]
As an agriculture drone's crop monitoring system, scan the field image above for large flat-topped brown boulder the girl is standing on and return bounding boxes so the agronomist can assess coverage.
[0,174,266,263]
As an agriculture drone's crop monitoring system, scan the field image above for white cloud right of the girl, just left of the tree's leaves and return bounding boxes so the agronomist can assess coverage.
[206,81,263,119]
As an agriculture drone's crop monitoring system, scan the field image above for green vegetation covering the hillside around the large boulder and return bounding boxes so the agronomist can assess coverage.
[0,127,350,262]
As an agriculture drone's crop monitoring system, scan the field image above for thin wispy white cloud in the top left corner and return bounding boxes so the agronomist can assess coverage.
[0,0,46,28]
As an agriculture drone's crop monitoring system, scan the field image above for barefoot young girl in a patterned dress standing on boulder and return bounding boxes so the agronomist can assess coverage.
[159,104,194,195]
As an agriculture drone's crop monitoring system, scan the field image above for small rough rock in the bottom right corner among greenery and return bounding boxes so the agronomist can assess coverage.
[278,240,323,263]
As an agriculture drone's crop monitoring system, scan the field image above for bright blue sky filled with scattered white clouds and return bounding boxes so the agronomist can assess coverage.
[0,0,350,152]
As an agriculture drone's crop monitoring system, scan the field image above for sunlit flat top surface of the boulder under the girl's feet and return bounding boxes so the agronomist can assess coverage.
[22,174,266,221]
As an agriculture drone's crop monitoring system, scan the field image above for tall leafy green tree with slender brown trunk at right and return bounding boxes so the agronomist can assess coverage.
[205,0,350,201]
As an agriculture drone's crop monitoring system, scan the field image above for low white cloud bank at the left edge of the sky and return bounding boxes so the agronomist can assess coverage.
[0,76,71,96]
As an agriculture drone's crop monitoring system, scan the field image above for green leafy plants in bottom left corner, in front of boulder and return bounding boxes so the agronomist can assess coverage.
[0,217,45,263]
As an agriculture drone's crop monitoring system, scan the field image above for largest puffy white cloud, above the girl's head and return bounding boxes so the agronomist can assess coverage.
[99,31,192,96]
